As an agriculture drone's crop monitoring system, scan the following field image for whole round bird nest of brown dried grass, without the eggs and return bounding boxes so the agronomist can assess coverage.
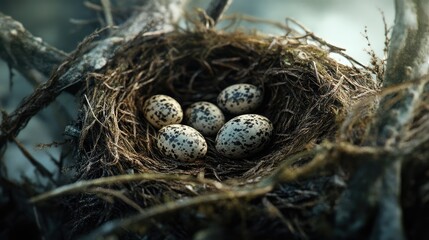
[67,24,377,239]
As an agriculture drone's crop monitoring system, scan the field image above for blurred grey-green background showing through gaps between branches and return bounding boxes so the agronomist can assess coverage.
[0,0,394,182]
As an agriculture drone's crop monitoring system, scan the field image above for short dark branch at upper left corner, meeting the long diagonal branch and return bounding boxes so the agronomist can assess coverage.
[0,12,67,83]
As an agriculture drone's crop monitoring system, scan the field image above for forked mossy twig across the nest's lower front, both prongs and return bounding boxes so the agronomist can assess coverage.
[30,139,383,239]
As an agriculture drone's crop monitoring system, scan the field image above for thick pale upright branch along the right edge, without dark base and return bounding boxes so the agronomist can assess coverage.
[372,0,429,239]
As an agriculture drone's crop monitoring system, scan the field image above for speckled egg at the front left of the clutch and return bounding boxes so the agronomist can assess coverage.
[157,124,207,161]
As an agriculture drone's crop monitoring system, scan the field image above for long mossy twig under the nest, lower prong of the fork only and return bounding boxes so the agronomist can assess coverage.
[78,143,380,239]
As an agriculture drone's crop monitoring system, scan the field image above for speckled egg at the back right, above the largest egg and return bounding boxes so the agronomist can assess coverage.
[217,83,263,115]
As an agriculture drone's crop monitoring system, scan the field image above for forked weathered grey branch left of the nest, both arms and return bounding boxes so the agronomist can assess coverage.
[0,0,184,149]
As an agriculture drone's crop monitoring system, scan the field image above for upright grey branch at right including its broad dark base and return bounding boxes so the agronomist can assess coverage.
[336,0,429,239]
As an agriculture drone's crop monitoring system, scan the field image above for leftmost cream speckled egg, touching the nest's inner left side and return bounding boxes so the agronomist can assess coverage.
[143,94,183,128]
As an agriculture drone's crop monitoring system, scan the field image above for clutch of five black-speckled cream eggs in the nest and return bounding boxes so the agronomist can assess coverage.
[143,84,273,161]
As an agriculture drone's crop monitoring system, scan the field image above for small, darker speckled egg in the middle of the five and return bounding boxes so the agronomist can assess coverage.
[185,102,225,136]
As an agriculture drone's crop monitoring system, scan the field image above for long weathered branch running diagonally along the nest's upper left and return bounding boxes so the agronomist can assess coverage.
[0,0,184,149]
